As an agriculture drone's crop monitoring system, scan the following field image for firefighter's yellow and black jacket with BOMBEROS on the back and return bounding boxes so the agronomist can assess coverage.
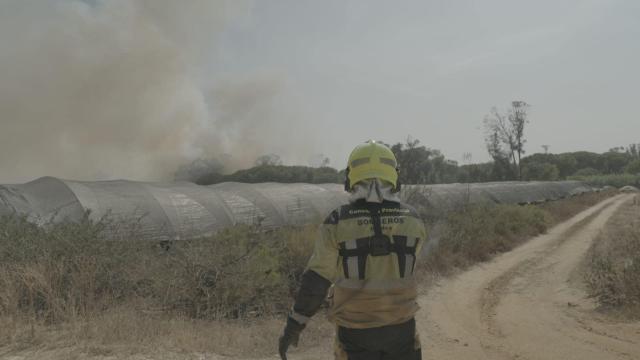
[290,200,426,329]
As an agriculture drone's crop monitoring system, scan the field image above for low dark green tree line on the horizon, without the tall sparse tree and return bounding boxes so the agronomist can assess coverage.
[178,144,640,185]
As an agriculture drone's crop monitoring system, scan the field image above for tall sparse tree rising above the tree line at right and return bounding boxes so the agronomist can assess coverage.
[484,101,529,179]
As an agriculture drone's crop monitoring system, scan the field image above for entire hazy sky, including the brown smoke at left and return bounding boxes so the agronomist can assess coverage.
[0,0,640,183]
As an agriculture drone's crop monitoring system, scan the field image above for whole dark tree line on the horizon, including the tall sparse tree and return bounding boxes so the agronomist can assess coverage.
[175,101,640,185]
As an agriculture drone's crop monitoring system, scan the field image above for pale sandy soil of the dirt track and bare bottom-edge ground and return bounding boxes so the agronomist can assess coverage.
[0,195,640,360]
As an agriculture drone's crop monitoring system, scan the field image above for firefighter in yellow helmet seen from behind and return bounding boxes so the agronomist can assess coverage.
[279,141,426,360]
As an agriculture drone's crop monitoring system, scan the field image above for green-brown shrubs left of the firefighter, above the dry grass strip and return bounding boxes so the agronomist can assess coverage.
[0,216,315,323]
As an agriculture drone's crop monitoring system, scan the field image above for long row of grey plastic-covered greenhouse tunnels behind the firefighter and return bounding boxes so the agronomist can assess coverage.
[0,177,593,240]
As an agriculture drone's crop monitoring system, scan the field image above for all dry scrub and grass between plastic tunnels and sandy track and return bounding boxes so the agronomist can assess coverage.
[0,192,613,356]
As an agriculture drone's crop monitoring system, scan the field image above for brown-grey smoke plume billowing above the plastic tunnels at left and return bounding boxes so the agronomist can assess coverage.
[0,0,310,183]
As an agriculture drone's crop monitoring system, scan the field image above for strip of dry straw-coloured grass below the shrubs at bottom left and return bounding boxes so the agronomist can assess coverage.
[0,306,333,357]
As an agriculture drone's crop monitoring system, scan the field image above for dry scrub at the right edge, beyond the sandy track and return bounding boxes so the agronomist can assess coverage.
[584,196,640,319]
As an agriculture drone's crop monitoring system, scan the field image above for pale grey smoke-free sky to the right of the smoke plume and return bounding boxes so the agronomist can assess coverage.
[216,0,640,166]
